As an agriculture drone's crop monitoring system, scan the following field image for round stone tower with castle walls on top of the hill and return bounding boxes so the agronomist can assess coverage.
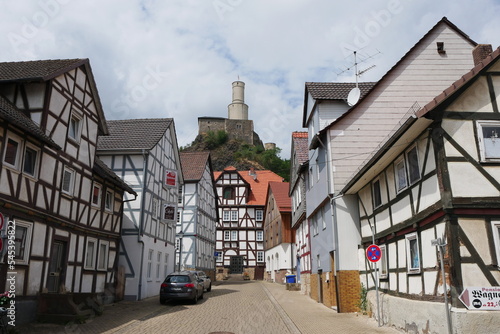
[198,81,262,146]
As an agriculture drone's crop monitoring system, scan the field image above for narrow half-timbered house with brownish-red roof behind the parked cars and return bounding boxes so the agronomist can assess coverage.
[177,152,218,281]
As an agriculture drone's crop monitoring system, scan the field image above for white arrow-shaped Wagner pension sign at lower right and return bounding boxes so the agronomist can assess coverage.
[458,286,500,311]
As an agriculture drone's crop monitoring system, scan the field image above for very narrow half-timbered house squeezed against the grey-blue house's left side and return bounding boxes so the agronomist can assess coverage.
[289,132,311,295]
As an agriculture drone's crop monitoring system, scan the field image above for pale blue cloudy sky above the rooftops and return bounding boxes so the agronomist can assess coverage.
[0,0,500,158]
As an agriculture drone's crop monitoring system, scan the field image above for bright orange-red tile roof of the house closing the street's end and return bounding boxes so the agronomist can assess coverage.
[214,166,288,206]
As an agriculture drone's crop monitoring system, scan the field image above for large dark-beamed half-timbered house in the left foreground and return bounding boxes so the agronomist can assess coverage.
[0,59,135,323]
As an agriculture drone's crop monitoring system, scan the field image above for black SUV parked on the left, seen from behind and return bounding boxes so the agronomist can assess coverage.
[160,271,204,304]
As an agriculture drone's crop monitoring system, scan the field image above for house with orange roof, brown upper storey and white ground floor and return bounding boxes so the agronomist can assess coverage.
[264,182,296,283]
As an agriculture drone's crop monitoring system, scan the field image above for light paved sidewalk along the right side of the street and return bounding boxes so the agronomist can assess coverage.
[260,282,400,334]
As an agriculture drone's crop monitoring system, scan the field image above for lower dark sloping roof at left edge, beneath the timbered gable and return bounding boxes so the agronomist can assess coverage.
[0,95,61,149]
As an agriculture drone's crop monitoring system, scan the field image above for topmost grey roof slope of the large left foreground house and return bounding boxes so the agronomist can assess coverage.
[0,59,88,82]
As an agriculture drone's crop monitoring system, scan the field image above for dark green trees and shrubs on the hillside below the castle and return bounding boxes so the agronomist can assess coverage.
[180,131,290,181]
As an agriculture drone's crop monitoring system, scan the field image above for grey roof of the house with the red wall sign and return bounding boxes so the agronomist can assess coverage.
[97,118,173,151]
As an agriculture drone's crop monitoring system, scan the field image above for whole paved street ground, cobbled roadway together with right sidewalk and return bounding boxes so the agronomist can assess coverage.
[17,281,398,334]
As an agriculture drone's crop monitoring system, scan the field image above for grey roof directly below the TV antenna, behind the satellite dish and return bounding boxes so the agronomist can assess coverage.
[306,82,376,100]
